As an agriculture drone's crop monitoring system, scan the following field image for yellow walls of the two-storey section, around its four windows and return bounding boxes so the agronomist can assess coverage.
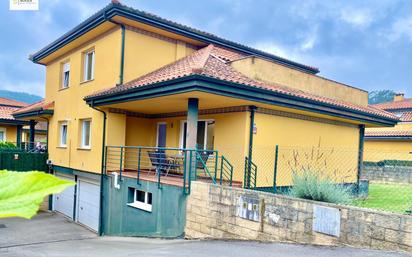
[45,28,198,173]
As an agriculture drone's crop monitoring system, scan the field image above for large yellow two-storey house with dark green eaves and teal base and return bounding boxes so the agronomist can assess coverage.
[15,1,398,234]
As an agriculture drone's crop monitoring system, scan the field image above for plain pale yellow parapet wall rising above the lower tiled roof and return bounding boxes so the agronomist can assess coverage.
[231,57,368,106]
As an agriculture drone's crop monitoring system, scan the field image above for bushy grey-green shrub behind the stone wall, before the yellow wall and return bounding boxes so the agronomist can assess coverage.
[289,171,351,204]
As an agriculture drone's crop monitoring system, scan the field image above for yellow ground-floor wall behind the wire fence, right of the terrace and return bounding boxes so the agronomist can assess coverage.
[253,113,359,187]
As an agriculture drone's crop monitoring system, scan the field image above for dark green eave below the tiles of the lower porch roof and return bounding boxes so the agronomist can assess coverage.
[84,75,398,126]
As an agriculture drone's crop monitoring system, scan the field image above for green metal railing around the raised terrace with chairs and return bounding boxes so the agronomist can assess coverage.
[104,146,233,194]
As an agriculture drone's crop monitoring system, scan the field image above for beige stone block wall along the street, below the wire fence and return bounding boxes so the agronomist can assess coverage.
[185,182,412,251]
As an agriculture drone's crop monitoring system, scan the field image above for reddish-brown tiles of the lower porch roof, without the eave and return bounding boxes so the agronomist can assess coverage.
[86,45,399,120]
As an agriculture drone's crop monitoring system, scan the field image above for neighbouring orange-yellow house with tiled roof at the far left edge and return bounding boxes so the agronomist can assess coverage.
[0,97,28,143]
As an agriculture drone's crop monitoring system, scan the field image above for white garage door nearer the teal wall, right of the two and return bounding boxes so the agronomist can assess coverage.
[77,179,100,231]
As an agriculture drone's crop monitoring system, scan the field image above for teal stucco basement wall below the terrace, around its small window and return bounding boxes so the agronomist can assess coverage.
[103,176,186,237]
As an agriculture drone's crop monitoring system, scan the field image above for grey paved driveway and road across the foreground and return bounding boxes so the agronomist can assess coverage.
[0,213,412,257]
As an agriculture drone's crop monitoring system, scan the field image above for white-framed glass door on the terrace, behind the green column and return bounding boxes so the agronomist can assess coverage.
[180,120,215,150]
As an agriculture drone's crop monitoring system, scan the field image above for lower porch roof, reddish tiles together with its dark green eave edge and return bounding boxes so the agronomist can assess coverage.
[85,45,399,125]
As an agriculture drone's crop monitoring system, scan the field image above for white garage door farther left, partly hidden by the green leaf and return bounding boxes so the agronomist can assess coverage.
[53,175,74,219]
